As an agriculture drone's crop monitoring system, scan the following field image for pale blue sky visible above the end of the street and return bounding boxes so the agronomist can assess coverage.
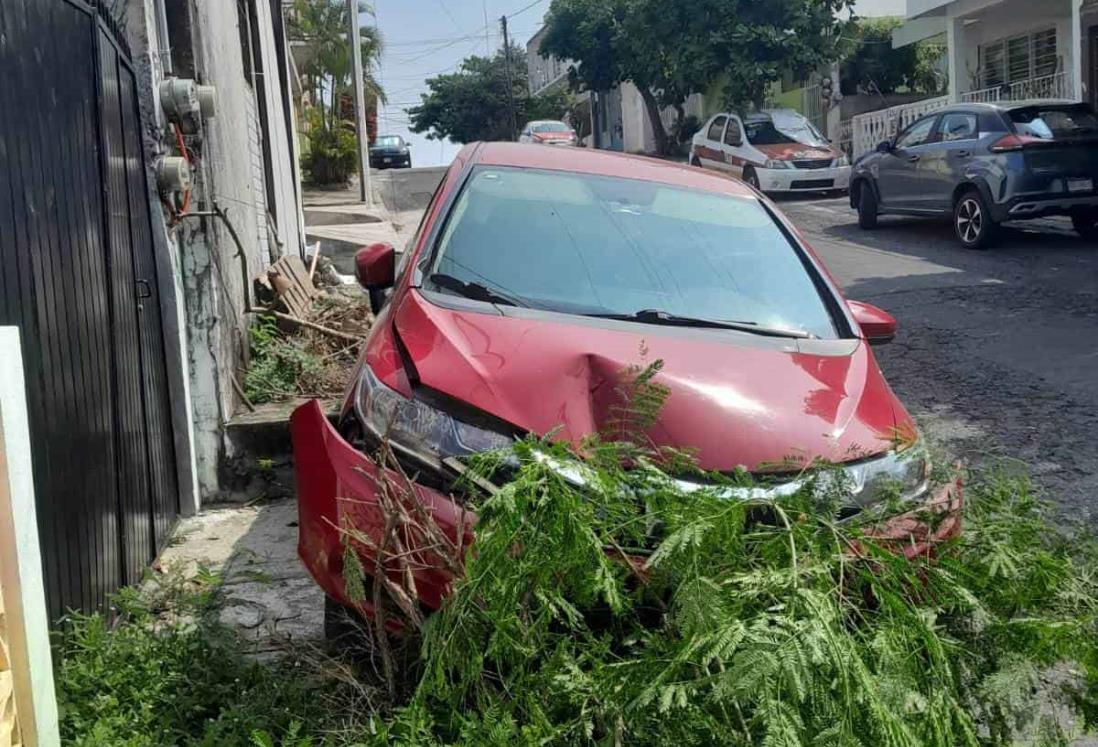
[373,0,549,166]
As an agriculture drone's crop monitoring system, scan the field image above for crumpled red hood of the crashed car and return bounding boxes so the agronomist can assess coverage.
[391,290,912,471]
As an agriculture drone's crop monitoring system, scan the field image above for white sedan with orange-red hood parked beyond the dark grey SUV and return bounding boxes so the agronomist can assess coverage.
[690,109,850,193]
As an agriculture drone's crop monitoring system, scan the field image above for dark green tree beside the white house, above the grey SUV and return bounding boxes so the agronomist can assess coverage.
[840,18,941,96]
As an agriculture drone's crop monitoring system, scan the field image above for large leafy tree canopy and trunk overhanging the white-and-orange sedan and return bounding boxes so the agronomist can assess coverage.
[541,0,853,153]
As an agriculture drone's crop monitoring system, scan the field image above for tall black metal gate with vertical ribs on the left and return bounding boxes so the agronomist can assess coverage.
[0,0,179,618]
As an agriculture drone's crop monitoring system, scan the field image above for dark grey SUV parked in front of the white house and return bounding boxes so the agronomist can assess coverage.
[850,101,1098,249]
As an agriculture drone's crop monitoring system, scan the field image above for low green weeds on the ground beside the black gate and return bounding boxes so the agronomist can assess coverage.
[56,572,376,747]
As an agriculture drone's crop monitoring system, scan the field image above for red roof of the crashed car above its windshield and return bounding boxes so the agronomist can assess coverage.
[470,143,755,197]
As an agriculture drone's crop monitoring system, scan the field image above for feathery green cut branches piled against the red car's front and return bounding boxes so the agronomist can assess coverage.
[362,428,1098,747]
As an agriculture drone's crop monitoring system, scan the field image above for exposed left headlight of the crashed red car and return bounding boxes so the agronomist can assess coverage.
[355,365,514,461]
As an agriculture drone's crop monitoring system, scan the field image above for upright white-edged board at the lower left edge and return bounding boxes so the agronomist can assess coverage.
[0,327,60,747]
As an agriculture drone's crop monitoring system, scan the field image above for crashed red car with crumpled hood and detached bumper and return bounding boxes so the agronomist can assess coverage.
[292,144,961,614]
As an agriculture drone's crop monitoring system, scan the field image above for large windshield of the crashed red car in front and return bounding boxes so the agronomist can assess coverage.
[426,167,837,338]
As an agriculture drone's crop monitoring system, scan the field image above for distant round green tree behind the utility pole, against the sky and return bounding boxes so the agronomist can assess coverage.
[407,46,569,143]
